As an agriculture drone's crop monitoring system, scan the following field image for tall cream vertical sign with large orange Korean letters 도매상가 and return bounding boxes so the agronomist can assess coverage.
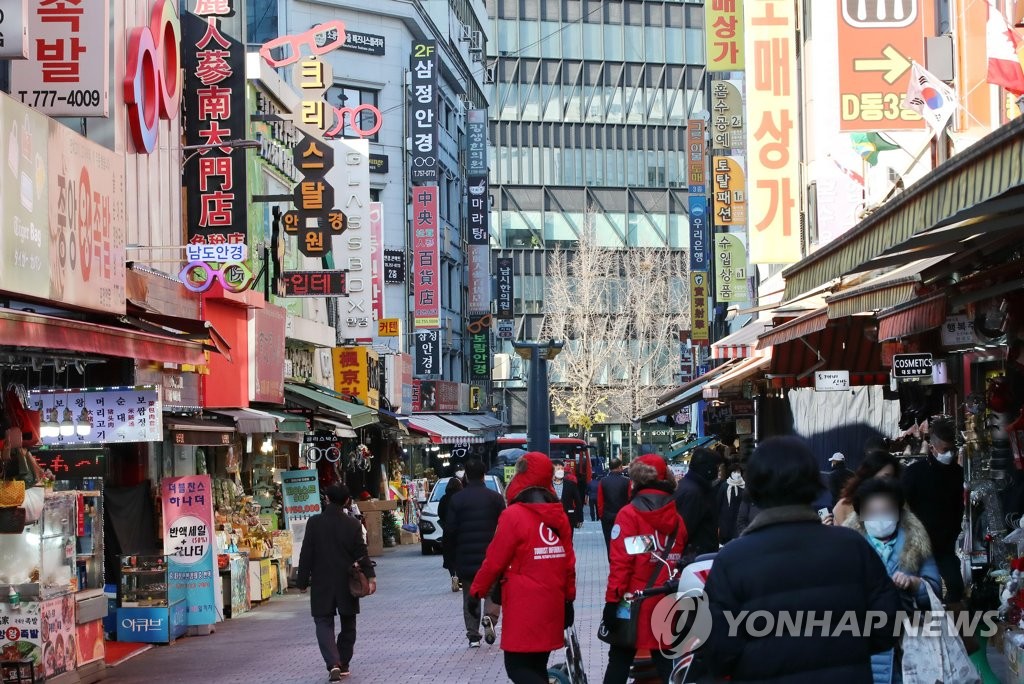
[744,0,801,263]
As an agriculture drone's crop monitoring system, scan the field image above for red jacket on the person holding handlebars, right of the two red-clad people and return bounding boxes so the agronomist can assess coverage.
[604,489,686,649]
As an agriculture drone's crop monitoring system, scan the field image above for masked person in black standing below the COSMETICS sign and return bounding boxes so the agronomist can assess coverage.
[903,419,964,603]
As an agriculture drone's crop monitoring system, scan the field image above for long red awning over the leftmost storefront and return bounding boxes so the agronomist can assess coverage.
[0,309,206,366]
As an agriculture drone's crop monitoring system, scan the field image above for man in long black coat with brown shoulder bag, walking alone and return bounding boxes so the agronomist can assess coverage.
[297,484,377,682]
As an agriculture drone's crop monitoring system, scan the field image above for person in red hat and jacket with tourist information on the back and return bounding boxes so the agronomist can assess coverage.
[470,452,575,684]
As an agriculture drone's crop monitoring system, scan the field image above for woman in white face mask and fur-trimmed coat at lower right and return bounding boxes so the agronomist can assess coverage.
[845,477,942,684]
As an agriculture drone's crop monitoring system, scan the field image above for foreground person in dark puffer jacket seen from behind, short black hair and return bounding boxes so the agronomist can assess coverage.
[697,437,900,684]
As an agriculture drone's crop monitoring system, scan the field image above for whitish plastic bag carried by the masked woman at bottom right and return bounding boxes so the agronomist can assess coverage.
[900,586,981,684]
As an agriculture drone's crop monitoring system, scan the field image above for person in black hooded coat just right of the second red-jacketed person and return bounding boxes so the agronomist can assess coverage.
[676,447,721,563]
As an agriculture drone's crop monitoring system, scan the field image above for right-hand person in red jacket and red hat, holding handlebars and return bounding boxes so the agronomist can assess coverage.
[604,454,686,684]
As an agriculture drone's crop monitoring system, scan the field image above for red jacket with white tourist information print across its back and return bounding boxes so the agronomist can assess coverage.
[470,493,575,653]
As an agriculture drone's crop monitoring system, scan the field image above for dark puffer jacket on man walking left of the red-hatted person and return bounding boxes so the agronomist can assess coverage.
[443,481,505,581]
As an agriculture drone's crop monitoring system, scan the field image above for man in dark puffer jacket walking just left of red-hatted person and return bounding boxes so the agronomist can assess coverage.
[443,459,505,648]
